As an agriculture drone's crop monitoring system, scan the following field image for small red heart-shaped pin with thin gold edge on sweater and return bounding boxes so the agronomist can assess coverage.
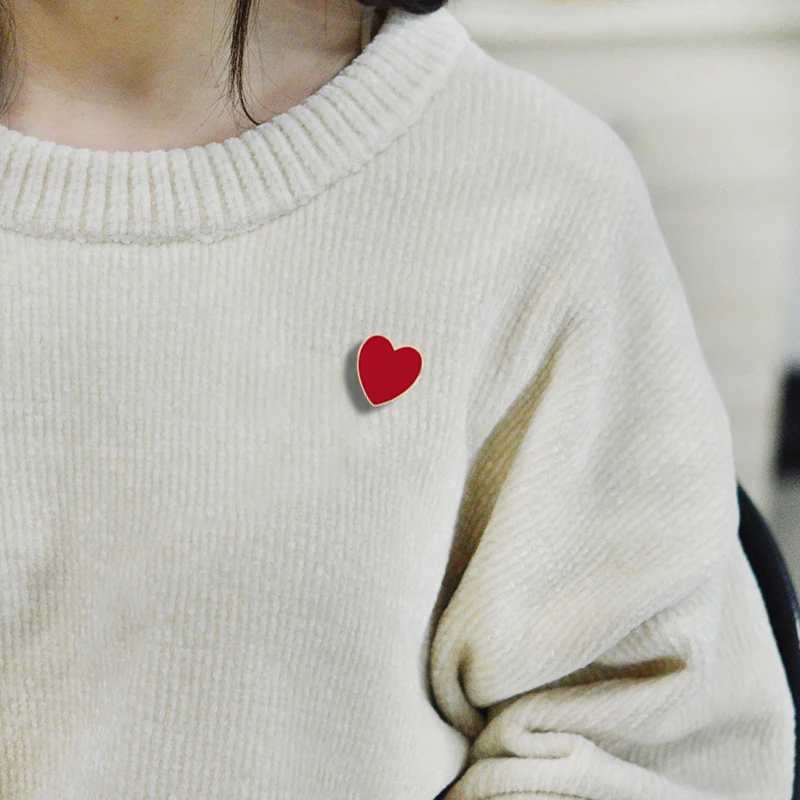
[358,333,422,406]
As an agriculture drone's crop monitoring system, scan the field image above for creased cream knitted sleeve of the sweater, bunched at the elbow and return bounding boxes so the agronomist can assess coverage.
[430,128,794,800]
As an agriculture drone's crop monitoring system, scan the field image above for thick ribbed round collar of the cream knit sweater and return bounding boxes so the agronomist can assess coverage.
[0,8,470,244]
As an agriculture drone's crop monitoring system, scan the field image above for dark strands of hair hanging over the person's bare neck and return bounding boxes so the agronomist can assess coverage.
[0,0,448,125]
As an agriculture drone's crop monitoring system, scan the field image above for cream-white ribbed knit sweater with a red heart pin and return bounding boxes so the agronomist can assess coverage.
[0,8,794,800]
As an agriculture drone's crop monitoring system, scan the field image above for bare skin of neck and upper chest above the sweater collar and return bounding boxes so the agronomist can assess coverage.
[0,0,382,151]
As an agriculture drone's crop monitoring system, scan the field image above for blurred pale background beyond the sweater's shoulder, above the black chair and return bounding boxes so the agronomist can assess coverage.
[448,0,800,588]
